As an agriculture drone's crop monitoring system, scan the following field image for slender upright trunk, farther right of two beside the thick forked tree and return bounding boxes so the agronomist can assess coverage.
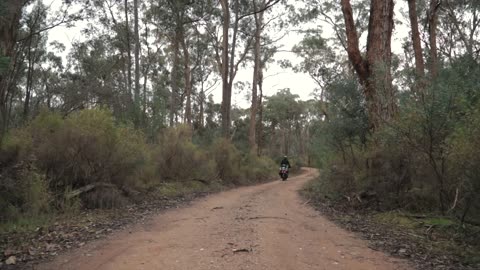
[428,0,441,80]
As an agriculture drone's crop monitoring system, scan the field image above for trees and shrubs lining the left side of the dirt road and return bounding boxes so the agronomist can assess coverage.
[0,0,314,243]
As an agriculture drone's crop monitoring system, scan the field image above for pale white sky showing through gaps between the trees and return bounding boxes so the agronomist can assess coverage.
[45,0,409,108]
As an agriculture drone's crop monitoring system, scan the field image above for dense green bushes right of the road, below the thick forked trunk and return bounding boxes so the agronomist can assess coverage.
[313,60,480,224]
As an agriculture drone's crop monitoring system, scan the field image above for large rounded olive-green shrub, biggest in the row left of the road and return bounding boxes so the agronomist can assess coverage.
[32,110,146,190]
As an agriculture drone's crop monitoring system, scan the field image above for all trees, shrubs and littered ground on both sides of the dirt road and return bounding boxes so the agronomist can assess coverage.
[0,0,480,268]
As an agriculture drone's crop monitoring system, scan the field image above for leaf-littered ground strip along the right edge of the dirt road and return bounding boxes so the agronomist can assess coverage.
[301,179,480,270]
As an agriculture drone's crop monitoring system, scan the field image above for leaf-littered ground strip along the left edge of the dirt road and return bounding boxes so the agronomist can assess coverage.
[0,187,214,270]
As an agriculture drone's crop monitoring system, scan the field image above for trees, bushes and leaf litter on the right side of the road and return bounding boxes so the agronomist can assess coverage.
[296,1,480,269]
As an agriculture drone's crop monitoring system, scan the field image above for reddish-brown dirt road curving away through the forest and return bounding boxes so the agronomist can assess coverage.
[38,169,410,270]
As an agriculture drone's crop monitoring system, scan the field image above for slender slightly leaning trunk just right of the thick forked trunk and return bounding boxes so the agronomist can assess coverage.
[408,0,425,94]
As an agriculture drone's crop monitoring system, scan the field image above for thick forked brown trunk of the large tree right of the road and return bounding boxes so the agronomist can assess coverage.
[341,0,396,132]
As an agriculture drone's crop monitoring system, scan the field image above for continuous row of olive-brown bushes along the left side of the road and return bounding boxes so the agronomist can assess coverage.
[0,109,277,228]
